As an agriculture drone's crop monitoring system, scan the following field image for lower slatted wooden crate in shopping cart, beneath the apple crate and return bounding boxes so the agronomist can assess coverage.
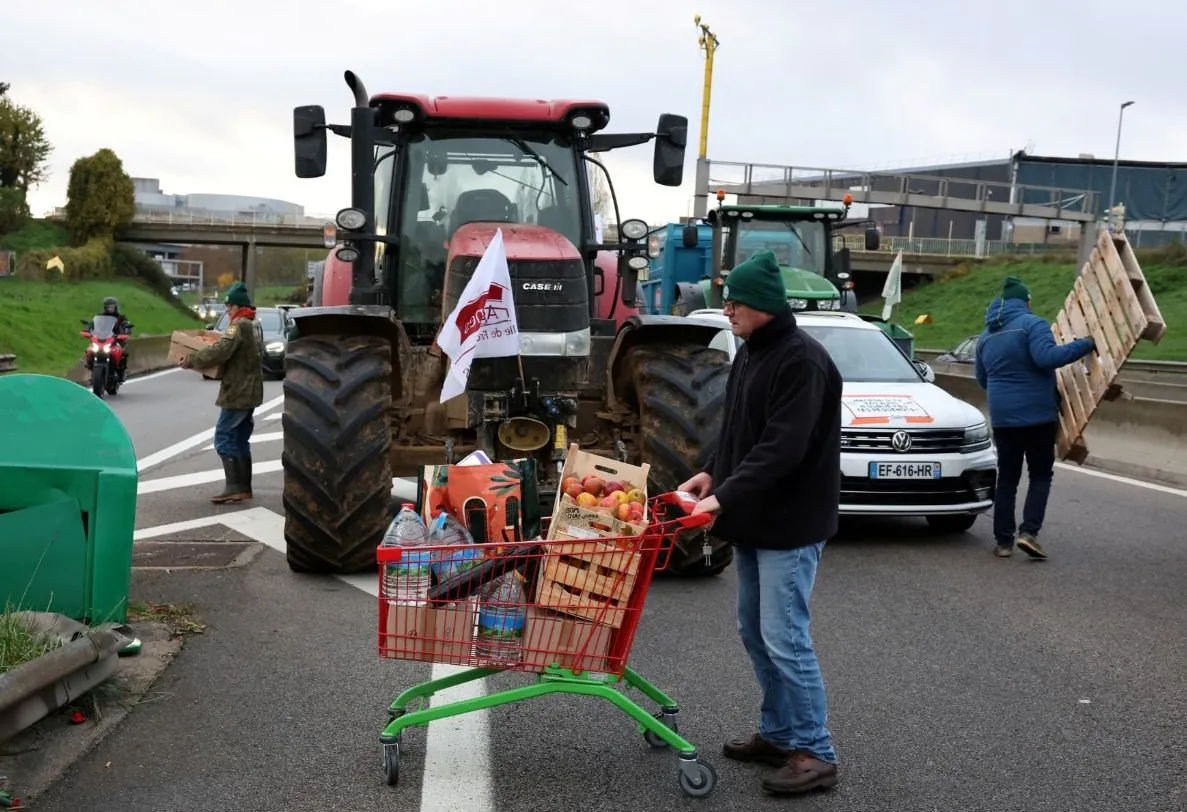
[535,539,642,628]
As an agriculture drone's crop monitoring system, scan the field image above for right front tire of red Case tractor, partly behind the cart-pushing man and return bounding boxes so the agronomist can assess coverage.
[627,344,734,577]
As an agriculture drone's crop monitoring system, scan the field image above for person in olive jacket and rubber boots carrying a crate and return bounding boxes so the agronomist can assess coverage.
[180,283,264,503]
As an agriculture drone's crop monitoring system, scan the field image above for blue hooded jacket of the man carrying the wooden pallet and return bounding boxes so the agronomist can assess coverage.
[976,298,1094,429]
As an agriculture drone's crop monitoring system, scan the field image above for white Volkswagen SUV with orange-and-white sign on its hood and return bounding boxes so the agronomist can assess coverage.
[688,309,997,533]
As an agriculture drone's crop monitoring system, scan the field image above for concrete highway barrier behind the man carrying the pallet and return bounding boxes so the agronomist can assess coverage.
[929,361,1187,488]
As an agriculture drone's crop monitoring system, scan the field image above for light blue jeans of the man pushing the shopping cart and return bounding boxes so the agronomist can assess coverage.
[734,541,837,763]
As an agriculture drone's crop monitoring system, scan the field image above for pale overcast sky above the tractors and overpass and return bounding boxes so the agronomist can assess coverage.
[0,0,1187,223]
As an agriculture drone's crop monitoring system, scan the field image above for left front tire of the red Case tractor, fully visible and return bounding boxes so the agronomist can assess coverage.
[280,336,392,575]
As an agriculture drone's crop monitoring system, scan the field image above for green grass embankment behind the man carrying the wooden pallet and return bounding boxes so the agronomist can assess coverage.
[861,247,1187,361]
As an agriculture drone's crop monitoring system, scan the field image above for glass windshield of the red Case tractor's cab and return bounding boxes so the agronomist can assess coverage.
[389,129,586,324]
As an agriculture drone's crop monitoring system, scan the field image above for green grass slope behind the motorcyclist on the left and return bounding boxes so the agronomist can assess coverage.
[0,279,202,375]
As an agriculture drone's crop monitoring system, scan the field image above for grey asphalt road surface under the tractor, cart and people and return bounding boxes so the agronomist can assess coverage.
[36,372,1187,812]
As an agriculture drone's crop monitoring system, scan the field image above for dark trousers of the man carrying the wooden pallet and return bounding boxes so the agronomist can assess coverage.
[994,423,1059,547]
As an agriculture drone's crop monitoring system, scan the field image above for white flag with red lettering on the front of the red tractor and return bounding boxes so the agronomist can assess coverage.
[437,229,520,404]
